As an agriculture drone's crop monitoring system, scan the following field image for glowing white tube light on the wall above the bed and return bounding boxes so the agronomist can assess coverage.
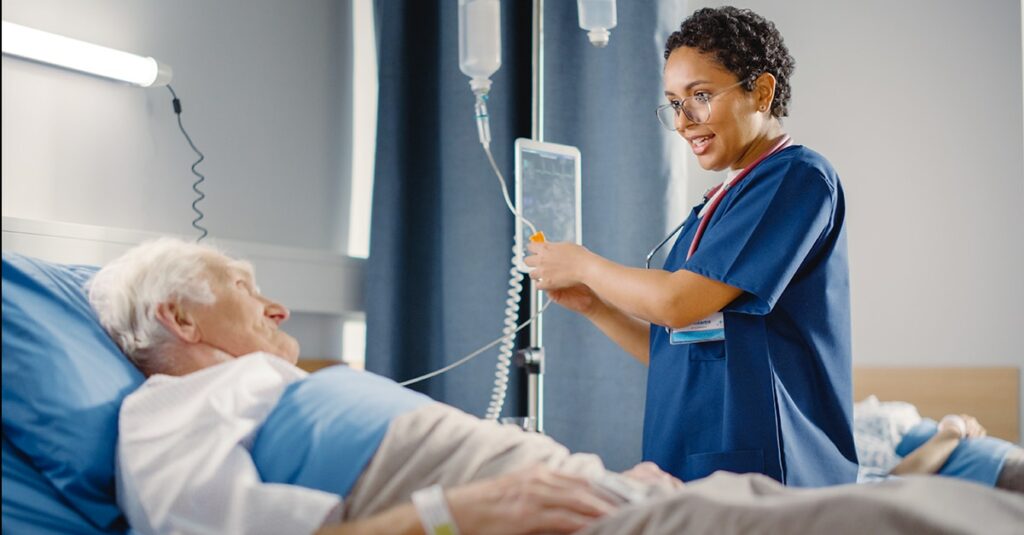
[3,20,171,87]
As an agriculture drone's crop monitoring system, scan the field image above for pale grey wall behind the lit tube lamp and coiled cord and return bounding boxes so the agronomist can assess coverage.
[2,0,360,356]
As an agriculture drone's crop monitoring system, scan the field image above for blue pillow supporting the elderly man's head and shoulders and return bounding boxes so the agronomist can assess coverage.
[2,251,143,530]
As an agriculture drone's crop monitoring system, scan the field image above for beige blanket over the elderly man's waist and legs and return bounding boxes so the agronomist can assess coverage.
[344,405,1024,535]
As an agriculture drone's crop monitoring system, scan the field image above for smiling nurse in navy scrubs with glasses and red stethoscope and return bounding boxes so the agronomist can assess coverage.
[525,7,857,486]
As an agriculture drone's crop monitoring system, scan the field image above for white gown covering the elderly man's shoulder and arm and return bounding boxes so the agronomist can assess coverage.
[118,354,341,534]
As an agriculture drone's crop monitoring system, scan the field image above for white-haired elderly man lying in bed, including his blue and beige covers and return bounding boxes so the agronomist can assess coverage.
[89,239,1024,535]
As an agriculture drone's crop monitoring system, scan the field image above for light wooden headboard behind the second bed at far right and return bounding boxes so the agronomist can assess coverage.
[853,367,1020,443]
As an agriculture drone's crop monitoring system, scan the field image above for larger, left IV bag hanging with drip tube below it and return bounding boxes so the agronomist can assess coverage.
[459,0,502,92]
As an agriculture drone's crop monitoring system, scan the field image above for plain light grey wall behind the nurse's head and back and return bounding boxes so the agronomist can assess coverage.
[688,0,1024,434]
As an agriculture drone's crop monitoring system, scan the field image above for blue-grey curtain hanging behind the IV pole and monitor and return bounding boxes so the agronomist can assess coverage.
[366,0,668,469]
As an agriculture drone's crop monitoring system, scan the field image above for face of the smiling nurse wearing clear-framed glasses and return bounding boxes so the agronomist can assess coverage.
[665,46,770,171]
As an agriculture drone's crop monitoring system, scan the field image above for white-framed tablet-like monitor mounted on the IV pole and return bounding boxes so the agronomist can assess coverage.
[515,137,583,262]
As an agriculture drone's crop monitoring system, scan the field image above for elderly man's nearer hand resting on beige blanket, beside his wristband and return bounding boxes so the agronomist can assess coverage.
[445,465,615,535]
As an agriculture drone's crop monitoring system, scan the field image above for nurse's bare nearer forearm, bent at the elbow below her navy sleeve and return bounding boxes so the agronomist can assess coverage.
[580,254,742,328]
